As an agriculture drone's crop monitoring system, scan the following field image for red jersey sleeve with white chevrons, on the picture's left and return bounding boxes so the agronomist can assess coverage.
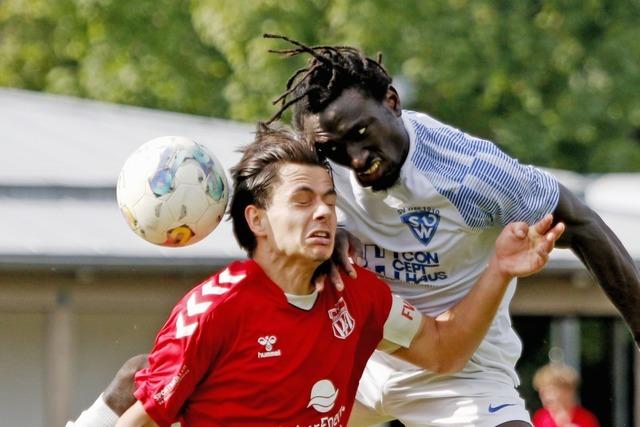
[134,283,228,427]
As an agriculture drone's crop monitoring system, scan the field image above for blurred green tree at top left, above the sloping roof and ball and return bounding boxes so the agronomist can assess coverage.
[0,0,230,116]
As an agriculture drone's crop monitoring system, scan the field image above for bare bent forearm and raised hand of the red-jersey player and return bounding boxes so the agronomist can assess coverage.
[393,215,564,373]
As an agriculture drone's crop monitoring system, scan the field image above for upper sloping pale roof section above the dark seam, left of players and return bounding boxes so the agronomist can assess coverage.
[0,88,254,187]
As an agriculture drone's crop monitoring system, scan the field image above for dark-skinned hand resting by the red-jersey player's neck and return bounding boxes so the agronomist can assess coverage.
[315,228,364,291]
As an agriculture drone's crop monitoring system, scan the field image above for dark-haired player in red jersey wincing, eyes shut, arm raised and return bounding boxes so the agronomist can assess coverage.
[117,124,564,427]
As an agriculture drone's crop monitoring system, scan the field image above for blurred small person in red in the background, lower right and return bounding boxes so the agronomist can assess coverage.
[533,362,600,427]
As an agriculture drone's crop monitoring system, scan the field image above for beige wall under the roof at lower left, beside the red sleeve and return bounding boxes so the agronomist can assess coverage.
[0,267,208,427]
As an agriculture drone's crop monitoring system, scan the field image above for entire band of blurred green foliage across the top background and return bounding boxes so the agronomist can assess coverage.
[0,0,640,172]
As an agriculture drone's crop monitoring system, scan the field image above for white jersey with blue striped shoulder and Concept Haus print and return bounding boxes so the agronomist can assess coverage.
[332,111,559,385]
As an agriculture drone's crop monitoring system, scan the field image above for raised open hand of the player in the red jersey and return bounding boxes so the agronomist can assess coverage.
[493,214,565,277]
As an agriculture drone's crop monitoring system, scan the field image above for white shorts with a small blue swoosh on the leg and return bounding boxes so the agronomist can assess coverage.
[349,352,531,427]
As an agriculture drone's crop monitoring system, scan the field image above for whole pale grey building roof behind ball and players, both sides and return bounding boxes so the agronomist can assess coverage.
[0,88,640,269]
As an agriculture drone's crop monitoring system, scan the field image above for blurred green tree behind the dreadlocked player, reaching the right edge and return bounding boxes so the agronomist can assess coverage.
[193,0,640,172]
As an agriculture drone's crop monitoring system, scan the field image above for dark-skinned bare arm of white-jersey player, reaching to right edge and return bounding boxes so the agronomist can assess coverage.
[554,185,640,345]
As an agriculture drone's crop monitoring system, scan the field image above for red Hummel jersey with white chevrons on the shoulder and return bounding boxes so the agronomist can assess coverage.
[135,260,392,427]
